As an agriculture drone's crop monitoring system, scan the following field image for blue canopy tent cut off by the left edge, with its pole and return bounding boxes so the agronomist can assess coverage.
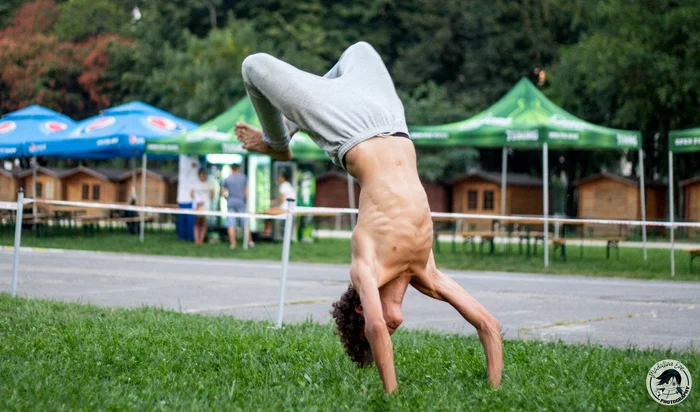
[0,105,75,215]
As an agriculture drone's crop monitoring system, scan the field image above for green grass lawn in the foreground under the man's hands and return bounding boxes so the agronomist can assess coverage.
[0,294,700,411]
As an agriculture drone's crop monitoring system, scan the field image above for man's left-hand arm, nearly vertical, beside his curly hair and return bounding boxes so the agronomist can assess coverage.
[350,263,397,393]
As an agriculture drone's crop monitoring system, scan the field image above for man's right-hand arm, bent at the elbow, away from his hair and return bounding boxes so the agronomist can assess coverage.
[411,257,503,387]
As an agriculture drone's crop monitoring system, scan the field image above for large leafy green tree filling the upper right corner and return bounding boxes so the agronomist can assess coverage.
[550,0,700,183]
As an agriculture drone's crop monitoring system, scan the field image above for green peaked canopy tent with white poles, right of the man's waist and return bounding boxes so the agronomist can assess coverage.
[410,78,647,266]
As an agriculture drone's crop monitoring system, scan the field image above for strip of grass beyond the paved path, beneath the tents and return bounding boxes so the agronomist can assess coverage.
[0,230,700,281]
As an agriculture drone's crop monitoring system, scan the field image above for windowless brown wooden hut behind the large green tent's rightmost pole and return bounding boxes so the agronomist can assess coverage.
[574,172,667,236]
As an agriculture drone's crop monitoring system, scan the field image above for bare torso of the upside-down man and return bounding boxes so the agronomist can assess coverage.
[345,136,433,313]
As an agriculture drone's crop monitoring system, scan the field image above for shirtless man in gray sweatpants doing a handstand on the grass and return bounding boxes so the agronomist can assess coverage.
[235,42,503,392]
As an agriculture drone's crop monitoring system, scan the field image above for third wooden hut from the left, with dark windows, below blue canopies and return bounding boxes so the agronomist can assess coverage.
[61,166,123,203]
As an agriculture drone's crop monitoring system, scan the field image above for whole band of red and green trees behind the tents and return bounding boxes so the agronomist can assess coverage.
[0,0,700,188]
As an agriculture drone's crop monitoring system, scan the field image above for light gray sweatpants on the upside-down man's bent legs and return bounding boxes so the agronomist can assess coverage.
[242,42,408,167]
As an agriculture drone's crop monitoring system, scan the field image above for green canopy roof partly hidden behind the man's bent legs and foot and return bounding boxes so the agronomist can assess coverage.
[146,97,328,160]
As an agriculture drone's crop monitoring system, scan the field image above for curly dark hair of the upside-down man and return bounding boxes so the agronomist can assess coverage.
[330,284,373,368]
